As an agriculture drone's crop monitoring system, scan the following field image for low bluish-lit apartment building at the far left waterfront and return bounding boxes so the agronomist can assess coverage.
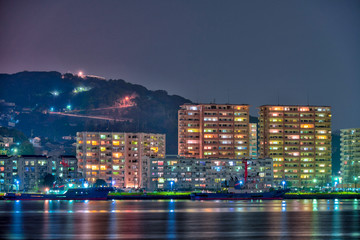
[0,155,80,191]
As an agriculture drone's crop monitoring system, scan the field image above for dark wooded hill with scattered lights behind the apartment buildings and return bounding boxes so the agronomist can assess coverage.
[0,72,191,153]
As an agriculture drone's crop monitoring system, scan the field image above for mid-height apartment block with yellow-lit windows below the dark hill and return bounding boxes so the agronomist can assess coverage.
[76,132,165,188]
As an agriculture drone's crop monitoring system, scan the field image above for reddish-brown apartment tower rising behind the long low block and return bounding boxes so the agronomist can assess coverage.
[178,104,249,159]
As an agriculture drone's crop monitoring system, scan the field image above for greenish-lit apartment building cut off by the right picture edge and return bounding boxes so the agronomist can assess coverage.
[340,128,360,187]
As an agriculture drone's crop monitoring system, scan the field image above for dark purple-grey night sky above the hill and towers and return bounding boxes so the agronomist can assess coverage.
[0,0,360,129]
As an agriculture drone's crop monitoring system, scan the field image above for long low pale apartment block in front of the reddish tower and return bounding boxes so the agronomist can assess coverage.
[142,156,273,191]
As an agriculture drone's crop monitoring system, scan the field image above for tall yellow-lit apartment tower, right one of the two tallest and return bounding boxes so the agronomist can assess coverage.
[259,105,331,187]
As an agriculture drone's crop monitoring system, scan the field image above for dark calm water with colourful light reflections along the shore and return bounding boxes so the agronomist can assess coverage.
[0,200,360,239]
